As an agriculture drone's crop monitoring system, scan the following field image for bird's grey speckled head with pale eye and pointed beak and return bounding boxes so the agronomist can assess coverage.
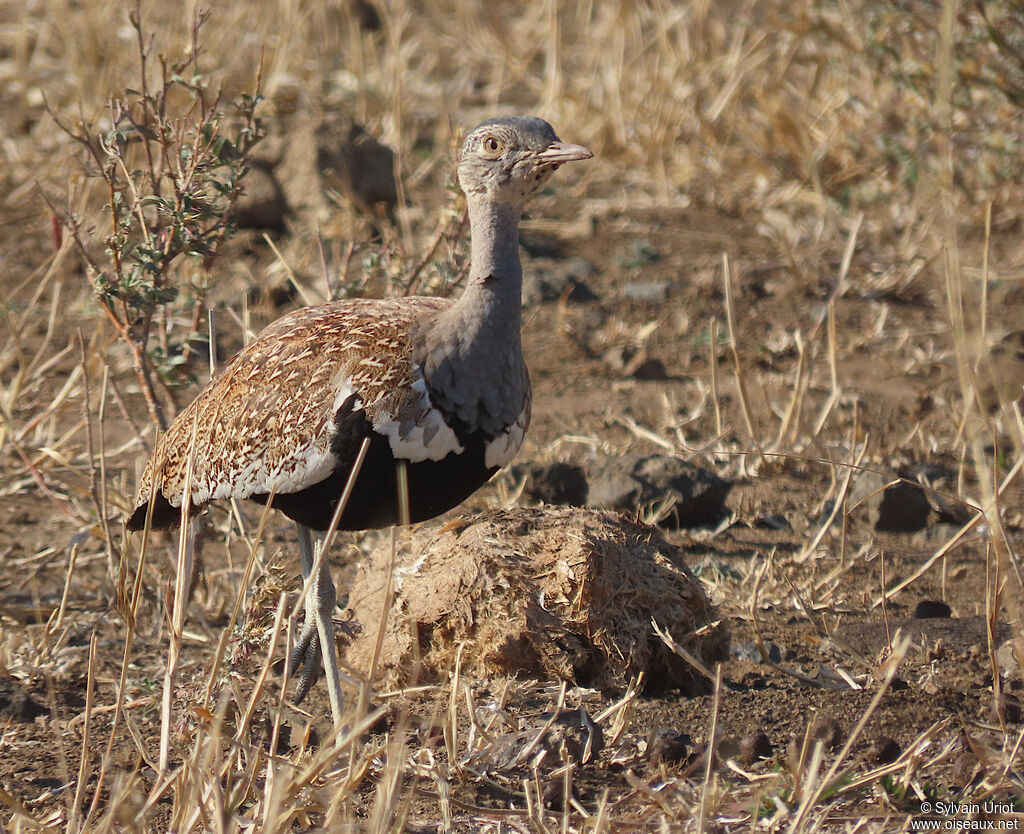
[459,116,594,203]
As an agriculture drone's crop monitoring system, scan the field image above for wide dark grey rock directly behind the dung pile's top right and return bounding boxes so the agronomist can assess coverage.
[587,455,732,528]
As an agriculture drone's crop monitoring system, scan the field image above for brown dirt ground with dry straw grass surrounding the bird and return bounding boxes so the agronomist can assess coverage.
[0,2,1024,832]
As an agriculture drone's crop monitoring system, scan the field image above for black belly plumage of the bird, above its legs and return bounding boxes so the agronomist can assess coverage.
[251,394,498,530]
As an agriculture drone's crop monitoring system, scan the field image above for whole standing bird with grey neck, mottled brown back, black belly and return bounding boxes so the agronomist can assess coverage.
[127,116,593,724]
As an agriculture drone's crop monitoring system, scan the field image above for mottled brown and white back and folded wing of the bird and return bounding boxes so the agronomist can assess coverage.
[129,298,450,529]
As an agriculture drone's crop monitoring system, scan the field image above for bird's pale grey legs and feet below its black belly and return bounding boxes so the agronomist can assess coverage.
[292,525,343,725]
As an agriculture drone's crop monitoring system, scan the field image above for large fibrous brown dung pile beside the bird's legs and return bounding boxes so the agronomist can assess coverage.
[346,507,728,694]
